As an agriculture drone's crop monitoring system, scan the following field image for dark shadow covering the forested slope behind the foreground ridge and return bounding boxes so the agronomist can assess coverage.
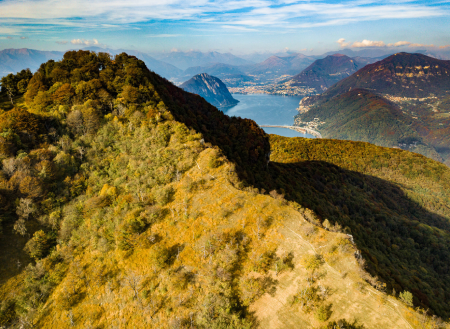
[269,161,450,318]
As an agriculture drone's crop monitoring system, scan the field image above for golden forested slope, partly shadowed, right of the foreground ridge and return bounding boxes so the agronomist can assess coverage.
[269,135,450,317]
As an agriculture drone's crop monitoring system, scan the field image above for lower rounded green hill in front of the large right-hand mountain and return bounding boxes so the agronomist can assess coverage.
[301,89,442,161]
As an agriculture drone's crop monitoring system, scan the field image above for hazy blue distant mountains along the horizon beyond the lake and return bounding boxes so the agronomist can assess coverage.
[4,47,450,92]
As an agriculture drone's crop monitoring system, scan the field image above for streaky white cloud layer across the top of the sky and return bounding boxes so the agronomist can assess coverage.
[0,0,444,31]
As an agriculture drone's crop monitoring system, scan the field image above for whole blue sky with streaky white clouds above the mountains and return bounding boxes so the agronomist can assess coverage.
[0,0,450,54]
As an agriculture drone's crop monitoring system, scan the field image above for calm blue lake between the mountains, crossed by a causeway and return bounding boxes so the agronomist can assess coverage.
[221,94,314,138]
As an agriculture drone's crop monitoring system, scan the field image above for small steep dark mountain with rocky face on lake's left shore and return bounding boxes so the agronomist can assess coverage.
[180,73,239,107]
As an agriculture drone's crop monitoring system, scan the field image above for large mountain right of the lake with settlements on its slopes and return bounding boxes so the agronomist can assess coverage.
[297,53,450,164]
